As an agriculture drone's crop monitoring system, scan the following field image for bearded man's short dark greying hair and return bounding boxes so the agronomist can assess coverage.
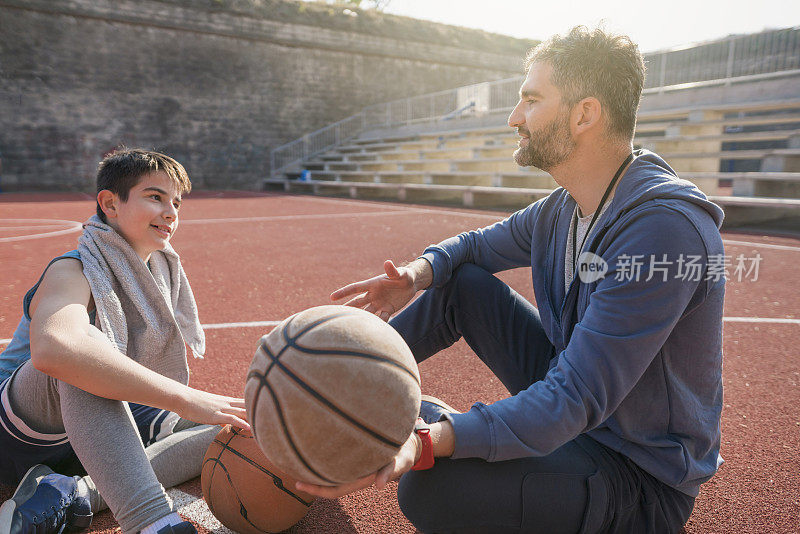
[525,26,644,141]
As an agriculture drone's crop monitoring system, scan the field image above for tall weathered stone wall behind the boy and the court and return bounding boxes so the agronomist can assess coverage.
[0,0,535,191]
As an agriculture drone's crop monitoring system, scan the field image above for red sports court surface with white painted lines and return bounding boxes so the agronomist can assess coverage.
[0,192,800,534]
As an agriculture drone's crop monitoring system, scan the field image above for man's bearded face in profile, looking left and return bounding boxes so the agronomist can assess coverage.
[508,62,575,171]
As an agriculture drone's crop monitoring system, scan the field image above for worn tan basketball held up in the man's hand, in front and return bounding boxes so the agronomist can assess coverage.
[245,306,420,486]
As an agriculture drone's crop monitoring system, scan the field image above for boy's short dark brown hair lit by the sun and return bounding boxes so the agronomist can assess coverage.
[97,147,192,223]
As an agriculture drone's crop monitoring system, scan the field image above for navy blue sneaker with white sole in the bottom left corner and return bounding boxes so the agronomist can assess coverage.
[0,465,92,534]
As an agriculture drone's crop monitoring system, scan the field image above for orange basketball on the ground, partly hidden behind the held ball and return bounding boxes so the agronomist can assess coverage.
[200,425,314,534]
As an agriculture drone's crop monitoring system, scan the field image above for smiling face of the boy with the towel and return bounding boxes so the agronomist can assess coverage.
[108,171,181,261]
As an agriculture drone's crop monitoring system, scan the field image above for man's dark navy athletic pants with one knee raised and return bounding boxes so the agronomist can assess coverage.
[391,264,694,534]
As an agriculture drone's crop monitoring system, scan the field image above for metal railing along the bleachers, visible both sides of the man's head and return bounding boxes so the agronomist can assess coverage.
[270,27,800,177]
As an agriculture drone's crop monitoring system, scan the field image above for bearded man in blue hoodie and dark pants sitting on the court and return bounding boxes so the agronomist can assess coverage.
[301,27,725,533]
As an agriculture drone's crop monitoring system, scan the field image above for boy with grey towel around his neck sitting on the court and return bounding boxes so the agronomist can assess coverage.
[0,149,249,534]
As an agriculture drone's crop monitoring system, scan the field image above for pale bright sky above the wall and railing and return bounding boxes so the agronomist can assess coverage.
[384,0,800,52]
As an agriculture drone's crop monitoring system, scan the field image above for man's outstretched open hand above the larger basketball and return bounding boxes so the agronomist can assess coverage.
[331,258,433,321]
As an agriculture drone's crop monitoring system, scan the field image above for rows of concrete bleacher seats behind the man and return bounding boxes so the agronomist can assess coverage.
[265,98,800,225]
